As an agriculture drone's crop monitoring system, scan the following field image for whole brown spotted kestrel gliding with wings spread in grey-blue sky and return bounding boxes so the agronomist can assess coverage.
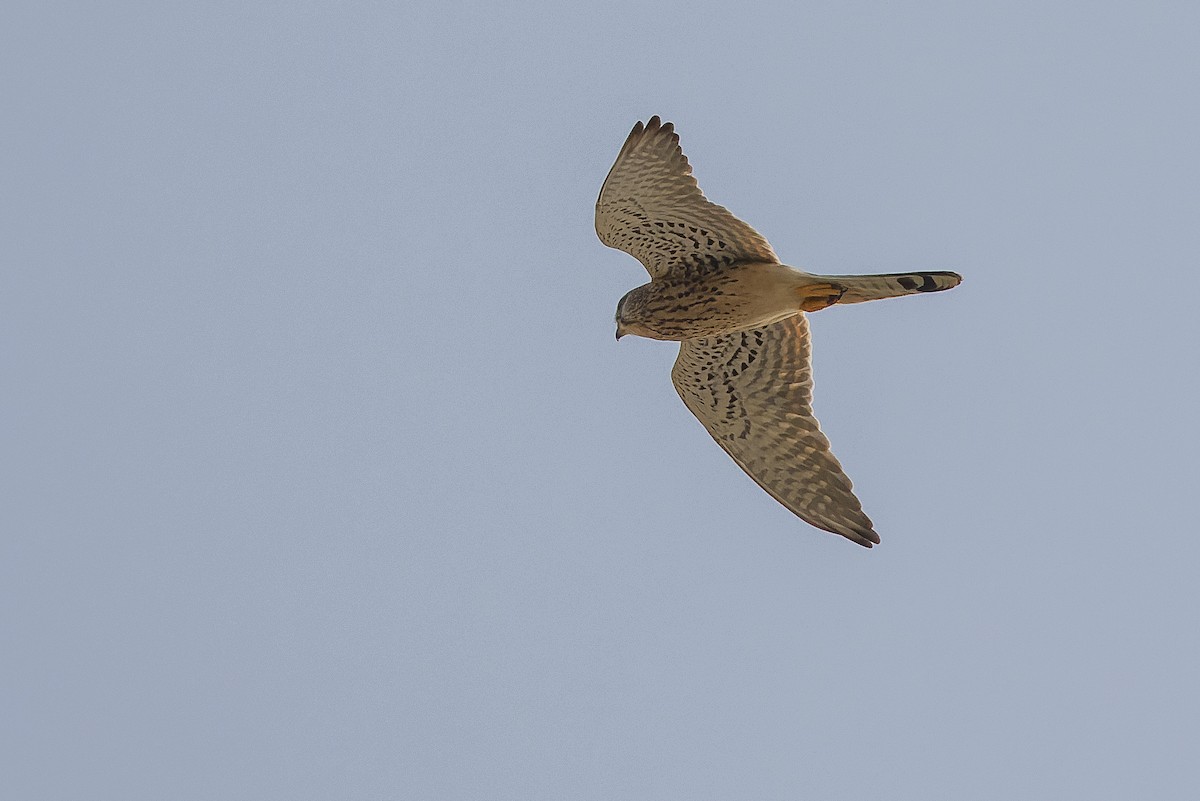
[596,116,962,548]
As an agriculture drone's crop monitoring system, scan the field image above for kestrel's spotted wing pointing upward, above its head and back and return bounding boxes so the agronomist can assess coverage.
[596,116,779,278]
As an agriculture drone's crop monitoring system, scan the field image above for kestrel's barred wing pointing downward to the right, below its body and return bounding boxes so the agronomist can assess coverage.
[671,314,880,548]
